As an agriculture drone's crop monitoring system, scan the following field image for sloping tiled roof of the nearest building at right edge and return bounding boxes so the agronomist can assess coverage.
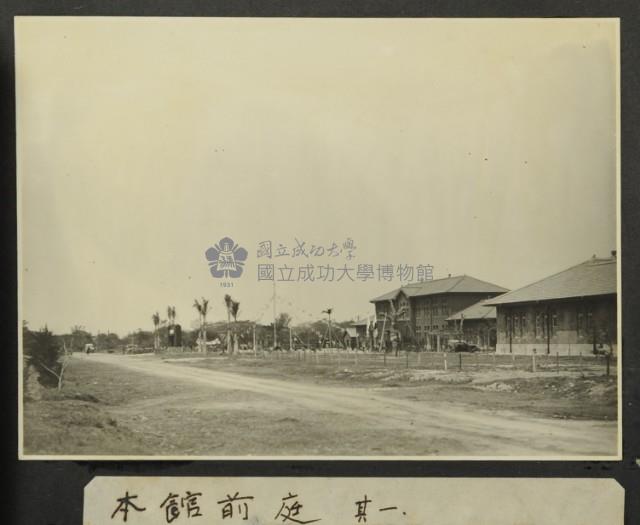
[487,257,617,305]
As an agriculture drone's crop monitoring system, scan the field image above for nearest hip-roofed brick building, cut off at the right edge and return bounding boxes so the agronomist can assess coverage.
[486,252,618,355]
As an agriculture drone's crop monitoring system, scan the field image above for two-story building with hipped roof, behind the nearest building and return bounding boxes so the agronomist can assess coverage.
[371,275,508,350]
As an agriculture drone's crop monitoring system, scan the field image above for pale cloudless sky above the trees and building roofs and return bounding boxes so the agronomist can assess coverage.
[16,17,618,335]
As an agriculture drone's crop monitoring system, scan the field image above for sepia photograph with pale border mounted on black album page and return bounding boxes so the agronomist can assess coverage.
[15,16,623,460]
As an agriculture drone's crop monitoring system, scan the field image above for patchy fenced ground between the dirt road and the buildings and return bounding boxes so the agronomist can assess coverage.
[168,354,618,421]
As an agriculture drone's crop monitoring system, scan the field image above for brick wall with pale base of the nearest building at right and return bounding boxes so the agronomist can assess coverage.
[496,296,617,355]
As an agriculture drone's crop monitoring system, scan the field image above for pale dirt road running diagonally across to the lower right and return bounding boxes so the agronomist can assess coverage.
[79,354,617,457]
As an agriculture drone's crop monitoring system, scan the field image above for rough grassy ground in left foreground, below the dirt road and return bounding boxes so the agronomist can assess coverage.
[23,358,450,456]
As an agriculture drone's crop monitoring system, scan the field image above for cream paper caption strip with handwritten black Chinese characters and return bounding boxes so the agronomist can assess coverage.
[83,474,625,525]
